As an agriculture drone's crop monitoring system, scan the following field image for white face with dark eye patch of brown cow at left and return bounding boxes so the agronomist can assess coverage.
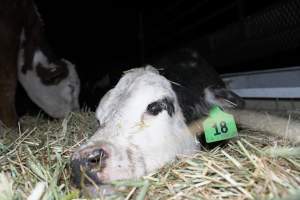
[18,32,80,118]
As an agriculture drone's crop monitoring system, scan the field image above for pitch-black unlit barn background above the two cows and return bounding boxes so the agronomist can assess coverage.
[17,0,300,111]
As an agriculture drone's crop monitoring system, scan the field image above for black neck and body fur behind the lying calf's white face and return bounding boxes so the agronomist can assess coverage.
[154,49,225,123]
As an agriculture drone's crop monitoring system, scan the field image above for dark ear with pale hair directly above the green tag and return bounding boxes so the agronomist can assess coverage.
[204,87,245,108]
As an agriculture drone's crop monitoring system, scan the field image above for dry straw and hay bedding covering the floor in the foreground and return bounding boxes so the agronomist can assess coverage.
[0,112,300,200]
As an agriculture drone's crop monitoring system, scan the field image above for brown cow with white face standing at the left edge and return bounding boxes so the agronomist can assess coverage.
[0,0,80,126]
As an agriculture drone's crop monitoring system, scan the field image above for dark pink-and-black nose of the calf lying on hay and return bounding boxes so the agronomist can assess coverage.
[71,148,108,187]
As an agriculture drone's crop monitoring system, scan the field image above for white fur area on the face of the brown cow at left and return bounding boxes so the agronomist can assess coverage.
[18,47,80,118]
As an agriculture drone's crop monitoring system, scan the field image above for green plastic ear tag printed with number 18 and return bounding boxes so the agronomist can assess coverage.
[203,106,237,143]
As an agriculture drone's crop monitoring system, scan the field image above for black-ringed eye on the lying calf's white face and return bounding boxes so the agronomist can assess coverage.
[147,98,175,116]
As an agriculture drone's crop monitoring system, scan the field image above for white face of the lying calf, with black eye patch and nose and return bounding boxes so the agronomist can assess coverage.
[71,66,197,188]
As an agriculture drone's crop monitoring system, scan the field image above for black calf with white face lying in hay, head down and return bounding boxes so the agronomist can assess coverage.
[71,50,300,193]
